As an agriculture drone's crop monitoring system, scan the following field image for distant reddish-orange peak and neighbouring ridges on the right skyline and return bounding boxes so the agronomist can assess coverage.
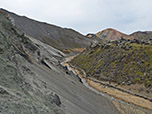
[87,28,152,43]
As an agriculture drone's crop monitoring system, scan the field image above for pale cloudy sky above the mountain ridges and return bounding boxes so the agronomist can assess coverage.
[0,0,152,34]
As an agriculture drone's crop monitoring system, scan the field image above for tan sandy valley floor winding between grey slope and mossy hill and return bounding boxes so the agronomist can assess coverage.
[63,56,152,114]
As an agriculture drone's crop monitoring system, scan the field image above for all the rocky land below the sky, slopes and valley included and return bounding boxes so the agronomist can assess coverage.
[0,9,152,114]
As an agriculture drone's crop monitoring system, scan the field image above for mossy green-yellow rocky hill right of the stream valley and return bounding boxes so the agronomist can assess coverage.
[71,39,152,90]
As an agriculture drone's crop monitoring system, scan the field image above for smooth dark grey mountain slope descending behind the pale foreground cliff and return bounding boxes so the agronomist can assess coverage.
[0,9,92,49]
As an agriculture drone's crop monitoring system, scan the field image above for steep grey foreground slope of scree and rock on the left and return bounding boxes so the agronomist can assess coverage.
[0,11,118,114]
